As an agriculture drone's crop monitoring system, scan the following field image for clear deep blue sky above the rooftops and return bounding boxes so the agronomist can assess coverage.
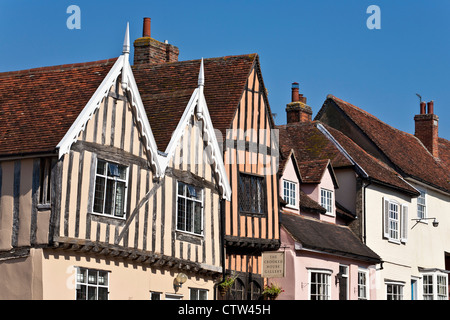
[0,0,450,139]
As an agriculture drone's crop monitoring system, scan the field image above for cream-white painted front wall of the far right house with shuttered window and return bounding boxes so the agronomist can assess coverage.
[366,184,450,300]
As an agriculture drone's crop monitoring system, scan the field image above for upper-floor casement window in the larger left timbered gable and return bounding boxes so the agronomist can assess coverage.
[93,159,128,218]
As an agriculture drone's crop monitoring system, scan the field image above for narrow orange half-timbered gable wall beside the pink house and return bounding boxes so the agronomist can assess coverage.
[224,67,279,273]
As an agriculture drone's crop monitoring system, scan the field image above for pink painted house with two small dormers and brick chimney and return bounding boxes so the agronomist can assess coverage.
[269,87,381,300]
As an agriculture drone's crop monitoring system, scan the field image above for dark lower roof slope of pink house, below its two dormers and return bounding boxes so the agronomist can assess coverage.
[281,213,381,263]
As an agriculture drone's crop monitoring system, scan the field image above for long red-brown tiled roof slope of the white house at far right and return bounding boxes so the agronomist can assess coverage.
[327,96,450,192]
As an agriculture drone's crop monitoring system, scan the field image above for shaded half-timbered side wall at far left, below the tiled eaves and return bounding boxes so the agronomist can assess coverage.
[0,156,56,251]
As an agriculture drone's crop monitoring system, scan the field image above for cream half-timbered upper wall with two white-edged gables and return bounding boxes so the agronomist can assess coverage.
[55,79,220,271]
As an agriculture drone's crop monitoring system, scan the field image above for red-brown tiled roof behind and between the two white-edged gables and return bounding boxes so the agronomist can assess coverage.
[133,54,258,151]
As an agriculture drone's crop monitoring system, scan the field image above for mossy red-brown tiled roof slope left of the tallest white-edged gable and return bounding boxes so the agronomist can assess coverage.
[0,59,116,156]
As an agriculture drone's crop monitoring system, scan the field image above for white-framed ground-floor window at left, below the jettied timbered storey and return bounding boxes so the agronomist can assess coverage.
[76,268,109,300]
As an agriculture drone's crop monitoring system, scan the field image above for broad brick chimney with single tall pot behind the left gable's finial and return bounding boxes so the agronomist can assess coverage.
[134,18,180,65]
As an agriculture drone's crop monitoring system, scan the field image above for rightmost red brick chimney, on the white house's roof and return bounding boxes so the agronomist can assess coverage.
[414,101,439,158]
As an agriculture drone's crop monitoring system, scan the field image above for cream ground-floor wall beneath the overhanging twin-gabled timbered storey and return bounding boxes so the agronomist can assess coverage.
[42,251,214,300]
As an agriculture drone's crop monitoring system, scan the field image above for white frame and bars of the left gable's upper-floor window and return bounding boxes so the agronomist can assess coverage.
[92,158,130,220]
